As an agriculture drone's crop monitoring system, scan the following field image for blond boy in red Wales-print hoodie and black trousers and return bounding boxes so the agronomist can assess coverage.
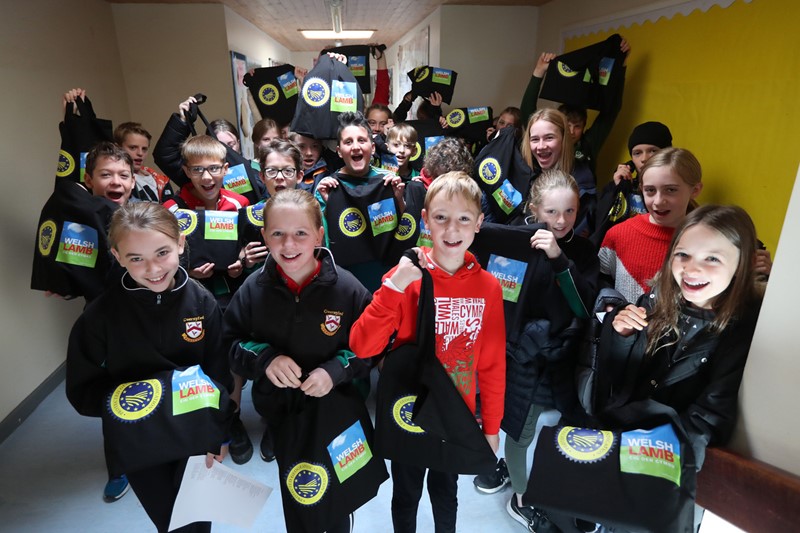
[350,172,506,533]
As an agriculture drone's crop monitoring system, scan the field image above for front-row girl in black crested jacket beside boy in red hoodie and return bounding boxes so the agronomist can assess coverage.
[225,189,378,532]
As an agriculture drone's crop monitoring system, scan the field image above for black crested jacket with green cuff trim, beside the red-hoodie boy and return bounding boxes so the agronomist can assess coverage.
[224,251,372,412]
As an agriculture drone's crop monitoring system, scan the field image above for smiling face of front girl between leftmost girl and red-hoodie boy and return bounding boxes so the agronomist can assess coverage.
[261,204,325,285]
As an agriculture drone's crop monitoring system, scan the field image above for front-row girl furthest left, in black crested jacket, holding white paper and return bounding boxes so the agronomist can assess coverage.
[66,202,233,531]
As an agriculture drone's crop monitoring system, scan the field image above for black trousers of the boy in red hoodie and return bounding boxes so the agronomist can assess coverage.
[392,461,458,533]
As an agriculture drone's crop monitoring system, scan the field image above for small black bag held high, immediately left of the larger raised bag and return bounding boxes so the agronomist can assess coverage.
[242,65,300,126]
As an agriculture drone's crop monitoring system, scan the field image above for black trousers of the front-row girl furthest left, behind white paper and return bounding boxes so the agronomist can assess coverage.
[128,459,211,533]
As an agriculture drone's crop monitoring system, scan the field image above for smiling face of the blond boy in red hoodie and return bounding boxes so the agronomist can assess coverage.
[422,194,483,274]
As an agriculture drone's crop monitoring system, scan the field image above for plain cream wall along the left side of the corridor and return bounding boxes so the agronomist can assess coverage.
[0,0,128,420]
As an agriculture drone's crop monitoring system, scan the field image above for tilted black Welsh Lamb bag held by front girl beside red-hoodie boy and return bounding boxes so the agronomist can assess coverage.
[270,383,389,533]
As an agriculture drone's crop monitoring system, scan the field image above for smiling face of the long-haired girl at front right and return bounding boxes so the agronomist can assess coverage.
[672,224,740,309]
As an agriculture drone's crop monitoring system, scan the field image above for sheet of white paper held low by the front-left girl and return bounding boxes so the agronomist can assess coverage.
[169,455,272,531]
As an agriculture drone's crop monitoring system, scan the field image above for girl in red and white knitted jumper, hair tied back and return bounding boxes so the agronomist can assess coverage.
[599,148,703,302]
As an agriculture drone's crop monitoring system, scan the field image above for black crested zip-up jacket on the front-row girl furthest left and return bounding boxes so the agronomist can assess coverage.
[66,268,233,416]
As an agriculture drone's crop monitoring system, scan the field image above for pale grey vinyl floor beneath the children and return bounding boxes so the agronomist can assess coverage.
[0,383,525,533]
